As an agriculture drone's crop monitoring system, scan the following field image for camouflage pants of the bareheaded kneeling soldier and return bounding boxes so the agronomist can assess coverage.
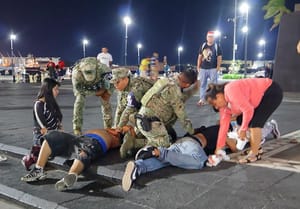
[136,119,170,147]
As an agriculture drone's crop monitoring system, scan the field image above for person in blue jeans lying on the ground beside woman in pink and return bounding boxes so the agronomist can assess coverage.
[122,120,280,191]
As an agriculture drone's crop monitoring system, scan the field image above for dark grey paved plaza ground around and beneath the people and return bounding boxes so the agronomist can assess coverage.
[0,81,300,209]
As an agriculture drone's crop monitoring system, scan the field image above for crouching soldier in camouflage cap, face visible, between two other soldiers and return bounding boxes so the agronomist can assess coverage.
[111,68,155,158]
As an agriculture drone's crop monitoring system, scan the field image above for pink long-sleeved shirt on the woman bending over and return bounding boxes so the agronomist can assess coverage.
[217,78,272,148]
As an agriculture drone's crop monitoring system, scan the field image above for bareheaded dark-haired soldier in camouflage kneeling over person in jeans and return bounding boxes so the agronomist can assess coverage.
[136,68,198,147]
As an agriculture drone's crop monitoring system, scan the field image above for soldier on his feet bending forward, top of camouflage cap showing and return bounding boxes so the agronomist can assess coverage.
[72,57,113,135]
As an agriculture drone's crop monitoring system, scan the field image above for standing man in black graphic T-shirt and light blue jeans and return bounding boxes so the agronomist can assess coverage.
[197,31,222,105]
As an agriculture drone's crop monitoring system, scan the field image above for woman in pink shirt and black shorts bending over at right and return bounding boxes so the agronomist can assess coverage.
[205,78,283,163]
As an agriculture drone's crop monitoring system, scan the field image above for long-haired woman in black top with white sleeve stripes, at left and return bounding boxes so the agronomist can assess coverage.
[22,78,63,170]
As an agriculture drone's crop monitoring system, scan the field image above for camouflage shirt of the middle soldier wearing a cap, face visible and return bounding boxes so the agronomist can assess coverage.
[115,77,155,127]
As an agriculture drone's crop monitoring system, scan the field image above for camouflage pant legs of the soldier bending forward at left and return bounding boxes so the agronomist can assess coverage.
[73,94,112,131]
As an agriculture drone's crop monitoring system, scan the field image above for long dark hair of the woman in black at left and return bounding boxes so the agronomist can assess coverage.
[37,78,62,121]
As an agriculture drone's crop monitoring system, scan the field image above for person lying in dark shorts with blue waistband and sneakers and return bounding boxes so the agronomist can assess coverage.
[21,127,133,191]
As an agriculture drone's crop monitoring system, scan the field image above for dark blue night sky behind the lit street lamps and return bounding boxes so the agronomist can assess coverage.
[0,0,300,65]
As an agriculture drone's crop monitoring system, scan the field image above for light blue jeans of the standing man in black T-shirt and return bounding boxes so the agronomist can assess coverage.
[199,68,218,101]
